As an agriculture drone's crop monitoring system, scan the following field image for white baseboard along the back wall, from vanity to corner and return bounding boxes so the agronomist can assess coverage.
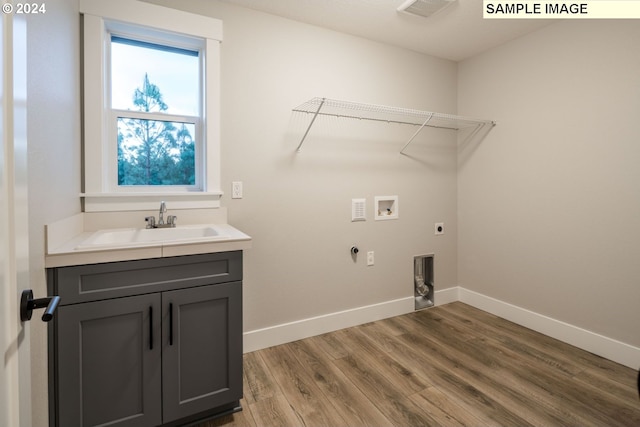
[244,287,458,353]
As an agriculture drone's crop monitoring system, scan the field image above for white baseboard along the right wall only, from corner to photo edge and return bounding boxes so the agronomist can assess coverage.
[458,287,640,369]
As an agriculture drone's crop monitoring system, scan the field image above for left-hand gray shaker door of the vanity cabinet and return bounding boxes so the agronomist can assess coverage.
[56,293,162,427]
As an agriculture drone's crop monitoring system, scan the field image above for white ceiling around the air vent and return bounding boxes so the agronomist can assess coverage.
[216,0,553,61]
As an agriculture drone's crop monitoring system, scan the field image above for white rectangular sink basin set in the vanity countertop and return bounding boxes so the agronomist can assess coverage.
[76,225,227,249]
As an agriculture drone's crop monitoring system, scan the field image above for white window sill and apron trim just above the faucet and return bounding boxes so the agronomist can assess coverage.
[80,191,223,212]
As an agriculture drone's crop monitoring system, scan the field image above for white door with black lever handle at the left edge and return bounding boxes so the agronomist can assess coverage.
[0,13,31,426]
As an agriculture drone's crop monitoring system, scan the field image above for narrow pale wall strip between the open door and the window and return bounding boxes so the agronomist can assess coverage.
[26,0,80,426]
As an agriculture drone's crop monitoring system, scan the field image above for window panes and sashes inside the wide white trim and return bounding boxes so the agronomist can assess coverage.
[110,37,202,188]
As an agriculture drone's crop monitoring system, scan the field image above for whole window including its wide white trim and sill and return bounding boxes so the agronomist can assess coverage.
[80,0,222,212]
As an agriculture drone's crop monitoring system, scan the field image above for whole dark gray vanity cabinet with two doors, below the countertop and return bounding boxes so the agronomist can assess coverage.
[47,251,242,427]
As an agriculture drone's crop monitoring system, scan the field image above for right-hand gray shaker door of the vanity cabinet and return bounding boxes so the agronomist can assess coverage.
[162,282,242,423]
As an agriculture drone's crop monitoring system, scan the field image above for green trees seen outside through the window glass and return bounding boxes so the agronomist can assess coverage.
[117,73,195,185]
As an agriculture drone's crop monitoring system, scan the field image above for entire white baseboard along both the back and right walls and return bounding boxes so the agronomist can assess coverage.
[244,286,640,369]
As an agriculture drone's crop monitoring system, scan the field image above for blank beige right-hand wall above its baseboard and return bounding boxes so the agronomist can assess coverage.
[458,20,640,346]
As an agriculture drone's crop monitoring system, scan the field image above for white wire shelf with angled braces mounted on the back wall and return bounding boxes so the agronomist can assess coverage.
[293,98,495,152]
